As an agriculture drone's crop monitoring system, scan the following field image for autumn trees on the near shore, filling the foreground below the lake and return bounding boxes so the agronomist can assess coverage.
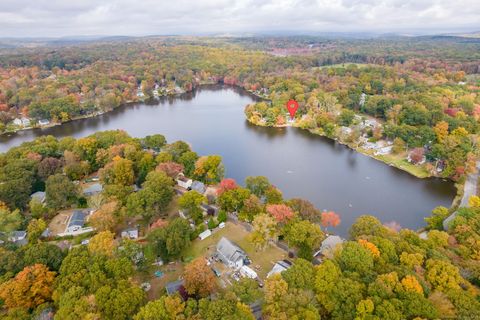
[0,131,480,320]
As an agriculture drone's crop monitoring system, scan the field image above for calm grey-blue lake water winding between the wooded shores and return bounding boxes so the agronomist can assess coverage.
[0,86,456,235]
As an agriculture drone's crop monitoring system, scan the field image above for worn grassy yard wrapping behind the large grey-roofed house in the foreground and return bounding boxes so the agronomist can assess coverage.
[184,222,287,279]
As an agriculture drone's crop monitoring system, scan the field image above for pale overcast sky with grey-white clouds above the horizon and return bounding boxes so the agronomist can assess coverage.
[0,0,480,37]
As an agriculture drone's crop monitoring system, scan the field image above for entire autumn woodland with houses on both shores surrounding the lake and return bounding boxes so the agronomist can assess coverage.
[0,36,480,320]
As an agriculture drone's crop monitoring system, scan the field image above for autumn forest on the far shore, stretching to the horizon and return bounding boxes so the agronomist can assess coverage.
[0,37,480,180]
